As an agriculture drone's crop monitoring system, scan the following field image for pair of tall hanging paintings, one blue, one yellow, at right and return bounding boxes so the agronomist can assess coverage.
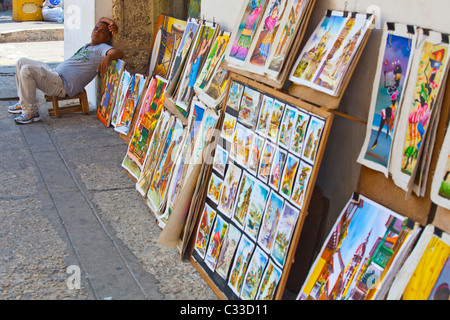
[358,23,449,196]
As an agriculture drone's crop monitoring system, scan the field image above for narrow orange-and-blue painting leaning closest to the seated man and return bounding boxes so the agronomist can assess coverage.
[97,59,125,127]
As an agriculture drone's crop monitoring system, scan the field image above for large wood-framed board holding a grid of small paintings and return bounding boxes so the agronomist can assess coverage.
[188,73,333,300]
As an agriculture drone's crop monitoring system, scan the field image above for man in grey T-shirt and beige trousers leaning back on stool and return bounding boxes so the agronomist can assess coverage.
[8,18,123,124]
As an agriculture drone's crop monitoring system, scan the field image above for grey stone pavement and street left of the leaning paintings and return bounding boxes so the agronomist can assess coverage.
[0,11,217,300]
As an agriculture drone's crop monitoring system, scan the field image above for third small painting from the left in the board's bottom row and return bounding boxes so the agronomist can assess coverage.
[216,223,242,280]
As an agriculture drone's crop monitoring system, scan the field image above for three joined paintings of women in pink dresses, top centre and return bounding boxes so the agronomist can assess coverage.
[226,0,312,79]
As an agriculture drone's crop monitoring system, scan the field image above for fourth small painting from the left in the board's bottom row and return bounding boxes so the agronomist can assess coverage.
[228,235,255,297]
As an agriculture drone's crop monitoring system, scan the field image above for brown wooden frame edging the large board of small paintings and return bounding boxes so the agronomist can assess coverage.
[186,73,334,300]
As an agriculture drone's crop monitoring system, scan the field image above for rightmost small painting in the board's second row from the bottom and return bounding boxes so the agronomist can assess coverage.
[270,202,300,267]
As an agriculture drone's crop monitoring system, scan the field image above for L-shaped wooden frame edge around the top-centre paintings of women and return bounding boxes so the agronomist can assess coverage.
[223,0,316,89]
